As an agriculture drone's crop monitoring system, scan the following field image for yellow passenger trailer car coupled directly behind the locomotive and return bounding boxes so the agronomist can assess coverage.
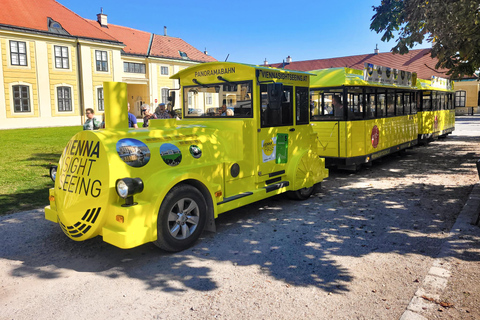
[310,64,418,170]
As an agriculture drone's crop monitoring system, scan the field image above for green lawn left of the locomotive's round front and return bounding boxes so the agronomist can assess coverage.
[0,126,82,215]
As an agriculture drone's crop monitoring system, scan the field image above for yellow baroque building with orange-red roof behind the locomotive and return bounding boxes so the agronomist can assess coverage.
[0,0,216,129]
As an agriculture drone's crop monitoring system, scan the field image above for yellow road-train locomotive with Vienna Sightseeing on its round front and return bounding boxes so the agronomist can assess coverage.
[45,62,328,252]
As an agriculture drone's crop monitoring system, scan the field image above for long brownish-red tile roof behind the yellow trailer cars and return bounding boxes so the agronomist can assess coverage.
[270,49,448,79]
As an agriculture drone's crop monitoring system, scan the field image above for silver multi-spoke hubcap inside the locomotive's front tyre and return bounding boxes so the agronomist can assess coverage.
[168,198,200,240]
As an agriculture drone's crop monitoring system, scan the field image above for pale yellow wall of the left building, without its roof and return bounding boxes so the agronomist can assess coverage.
[0,30,206,129]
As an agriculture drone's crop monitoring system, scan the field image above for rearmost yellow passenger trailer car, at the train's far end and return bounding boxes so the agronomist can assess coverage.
[417,77,455,144]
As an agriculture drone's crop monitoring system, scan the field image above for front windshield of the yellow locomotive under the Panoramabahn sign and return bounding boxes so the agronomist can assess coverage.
[183,81,253,118]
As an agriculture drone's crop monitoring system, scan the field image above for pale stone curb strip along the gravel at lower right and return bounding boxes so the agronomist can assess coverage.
[400,183,480,320]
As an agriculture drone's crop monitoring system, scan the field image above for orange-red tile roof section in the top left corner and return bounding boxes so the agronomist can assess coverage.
[0,0,118,42]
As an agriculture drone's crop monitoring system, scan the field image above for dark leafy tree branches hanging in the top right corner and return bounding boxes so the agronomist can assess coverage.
[370,0,480,79]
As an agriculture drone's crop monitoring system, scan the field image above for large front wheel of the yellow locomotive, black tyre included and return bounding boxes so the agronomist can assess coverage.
[154,185,207,252]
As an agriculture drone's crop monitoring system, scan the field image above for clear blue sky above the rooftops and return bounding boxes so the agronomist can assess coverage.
[57,0,430,64]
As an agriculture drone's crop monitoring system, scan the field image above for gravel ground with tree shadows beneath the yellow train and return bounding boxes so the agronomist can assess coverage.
[0,117,480,319]
